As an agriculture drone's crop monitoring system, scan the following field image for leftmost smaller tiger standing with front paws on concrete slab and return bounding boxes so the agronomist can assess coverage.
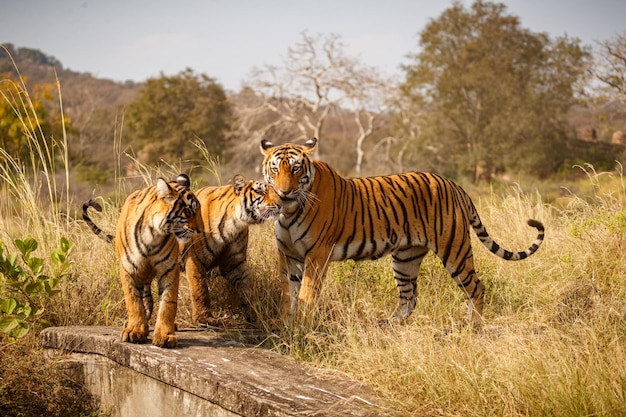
[83,174,197,348]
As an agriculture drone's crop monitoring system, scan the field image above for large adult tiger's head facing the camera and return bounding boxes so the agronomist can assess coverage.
[261,138,317,204]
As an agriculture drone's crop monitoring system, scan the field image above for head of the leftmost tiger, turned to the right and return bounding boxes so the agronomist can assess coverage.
[155,174,202,243]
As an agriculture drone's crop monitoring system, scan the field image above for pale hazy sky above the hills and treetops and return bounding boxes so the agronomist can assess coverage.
[0,0,626,91]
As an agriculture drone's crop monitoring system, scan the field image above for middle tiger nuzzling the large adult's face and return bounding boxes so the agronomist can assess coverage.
[182,175,282,324]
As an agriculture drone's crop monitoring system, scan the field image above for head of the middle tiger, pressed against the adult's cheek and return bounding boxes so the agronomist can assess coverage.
[232,175,282,224]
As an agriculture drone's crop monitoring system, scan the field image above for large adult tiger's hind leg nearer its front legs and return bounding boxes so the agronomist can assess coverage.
[392,246,428,320]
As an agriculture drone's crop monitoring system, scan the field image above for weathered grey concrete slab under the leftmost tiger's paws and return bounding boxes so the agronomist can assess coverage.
[41,327,386,417]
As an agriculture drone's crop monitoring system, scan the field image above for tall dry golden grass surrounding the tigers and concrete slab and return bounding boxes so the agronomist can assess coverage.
[0,66,626,416]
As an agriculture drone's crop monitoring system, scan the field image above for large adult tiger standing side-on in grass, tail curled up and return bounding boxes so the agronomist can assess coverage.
[261,138,544,325]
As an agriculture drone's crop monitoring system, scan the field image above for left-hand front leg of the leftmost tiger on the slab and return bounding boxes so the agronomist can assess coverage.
[120,266,150,343]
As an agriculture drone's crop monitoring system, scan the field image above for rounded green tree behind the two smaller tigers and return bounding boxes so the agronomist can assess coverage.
[125,69,231,171]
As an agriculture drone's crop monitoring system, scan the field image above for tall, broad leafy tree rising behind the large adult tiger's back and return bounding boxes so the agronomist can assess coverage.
[401,0,589,178]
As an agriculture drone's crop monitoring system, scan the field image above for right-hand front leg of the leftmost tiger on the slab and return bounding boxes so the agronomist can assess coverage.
[152,260,180,348]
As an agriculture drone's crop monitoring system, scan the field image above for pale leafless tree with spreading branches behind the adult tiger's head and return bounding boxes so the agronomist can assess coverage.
[236,32,389,174]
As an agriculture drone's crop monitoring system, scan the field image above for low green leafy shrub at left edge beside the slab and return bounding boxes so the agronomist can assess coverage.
[0,238,72,339]
